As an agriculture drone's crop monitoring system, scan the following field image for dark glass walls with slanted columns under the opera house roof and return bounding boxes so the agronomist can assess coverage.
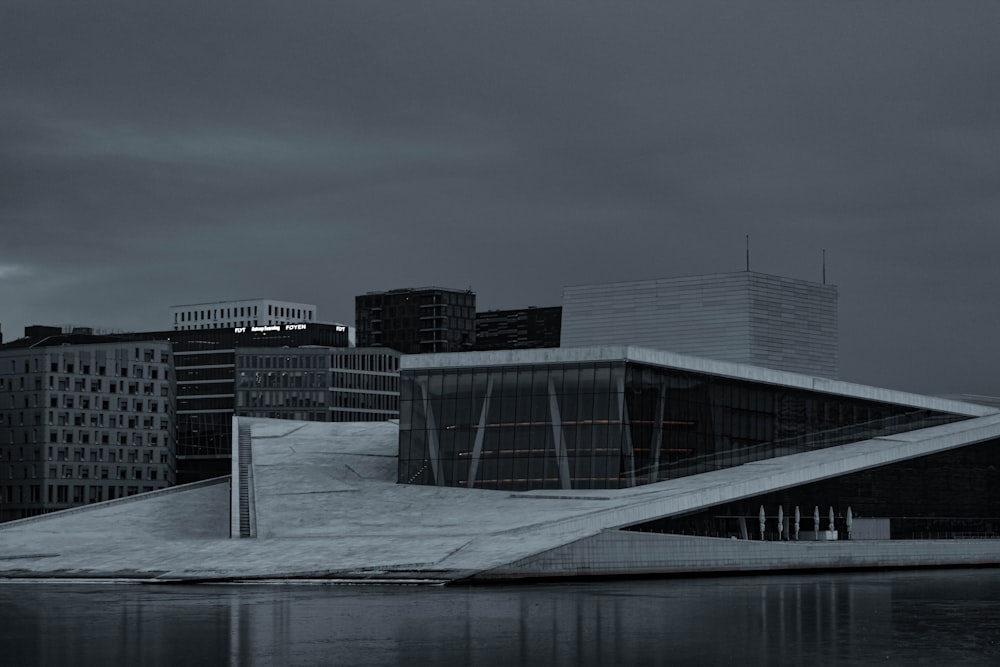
[398,360,966,491]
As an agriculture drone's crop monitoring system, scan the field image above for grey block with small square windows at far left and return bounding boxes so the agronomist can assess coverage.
[0,335,176,521]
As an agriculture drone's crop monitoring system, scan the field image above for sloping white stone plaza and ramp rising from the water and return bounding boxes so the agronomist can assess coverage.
[0,415,1000,580]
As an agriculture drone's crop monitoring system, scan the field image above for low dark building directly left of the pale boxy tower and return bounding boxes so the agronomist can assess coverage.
[476,306,562,350]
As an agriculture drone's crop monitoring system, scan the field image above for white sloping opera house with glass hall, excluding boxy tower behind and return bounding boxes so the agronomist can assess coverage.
[0,346,1000,582]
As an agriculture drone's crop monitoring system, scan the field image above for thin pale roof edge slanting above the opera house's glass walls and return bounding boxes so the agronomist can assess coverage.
[400,345,1000,417]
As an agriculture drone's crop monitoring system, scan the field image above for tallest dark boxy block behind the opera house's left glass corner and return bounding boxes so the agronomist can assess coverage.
[354,287,476,354]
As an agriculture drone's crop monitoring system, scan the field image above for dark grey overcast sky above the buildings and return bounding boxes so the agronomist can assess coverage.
[0,0,1000,395]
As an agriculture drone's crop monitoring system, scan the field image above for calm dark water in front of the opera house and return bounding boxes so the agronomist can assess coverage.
[0,570,1000,667]
